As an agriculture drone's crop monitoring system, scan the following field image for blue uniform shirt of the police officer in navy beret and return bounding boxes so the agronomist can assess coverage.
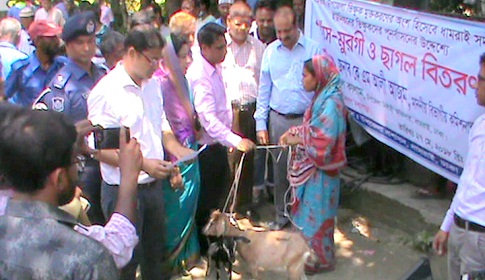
[33,59,106,122]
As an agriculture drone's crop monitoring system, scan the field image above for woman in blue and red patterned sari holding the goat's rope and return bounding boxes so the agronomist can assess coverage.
[280,54,346,274]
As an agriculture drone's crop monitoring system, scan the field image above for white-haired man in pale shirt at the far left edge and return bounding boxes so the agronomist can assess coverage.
[0,17,27,100]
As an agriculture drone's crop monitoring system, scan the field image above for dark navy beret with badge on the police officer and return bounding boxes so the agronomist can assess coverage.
[62,12,96,42]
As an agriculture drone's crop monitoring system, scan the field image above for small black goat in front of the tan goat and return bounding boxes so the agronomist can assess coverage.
[206,236,249,280]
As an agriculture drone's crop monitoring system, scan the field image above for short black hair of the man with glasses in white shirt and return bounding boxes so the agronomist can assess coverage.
[125,28,165,52]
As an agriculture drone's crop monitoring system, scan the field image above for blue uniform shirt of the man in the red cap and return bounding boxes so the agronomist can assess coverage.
[5,52,67,106]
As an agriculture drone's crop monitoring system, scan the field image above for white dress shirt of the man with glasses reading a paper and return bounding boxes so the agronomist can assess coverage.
[88,62,171,185]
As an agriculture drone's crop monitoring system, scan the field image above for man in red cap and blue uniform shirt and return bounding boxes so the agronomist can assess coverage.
[5,20,67,107]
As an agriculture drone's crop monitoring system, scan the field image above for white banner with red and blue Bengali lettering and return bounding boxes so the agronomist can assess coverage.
[305,0,485,182]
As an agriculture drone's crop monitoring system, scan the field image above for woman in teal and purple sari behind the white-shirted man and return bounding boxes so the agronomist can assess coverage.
[155,34,200,274]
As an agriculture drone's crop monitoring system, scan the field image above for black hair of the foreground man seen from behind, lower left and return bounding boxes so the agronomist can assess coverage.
[0,107,77,193]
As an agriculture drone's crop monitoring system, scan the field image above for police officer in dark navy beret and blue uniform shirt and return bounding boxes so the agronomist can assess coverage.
[34,12,106,224]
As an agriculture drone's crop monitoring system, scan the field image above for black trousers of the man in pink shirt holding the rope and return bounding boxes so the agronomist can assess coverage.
[195,144,229,255]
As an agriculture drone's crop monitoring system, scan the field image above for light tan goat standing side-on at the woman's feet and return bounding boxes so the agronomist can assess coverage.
[203,210,312,280]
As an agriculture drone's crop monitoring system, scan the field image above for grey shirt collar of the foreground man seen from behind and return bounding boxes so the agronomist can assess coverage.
[6,199,77,226]
